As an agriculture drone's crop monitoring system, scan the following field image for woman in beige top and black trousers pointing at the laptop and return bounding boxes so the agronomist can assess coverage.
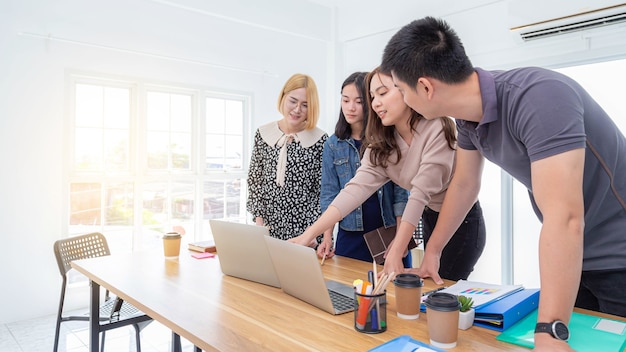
[290,68,485,280]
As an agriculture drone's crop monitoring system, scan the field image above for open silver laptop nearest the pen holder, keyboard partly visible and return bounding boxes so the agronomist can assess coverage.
[265,236,354,314]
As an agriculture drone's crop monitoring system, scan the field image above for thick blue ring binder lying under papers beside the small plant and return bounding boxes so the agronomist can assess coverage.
[474,289,539,331]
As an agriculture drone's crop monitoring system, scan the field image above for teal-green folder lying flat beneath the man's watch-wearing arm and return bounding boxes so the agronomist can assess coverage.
[496,309,626,352]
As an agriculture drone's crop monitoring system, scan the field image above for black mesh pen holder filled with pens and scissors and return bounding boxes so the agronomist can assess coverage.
[354,291,387,334]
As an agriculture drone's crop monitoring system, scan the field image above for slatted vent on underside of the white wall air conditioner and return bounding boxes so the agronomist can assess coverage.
[511,4,626,41]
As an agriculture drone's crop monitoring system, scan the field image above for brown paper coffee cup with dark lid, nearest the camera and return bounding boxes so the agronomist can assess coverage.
[424,292,461,349]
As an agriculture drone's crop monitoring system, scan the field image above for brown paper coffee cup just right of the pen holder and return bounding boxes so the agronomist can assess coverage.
[393,274,424,320]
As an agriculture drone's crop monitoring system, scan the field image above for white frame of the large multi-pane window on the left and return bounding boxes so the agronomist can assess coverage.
[62,72,252,251]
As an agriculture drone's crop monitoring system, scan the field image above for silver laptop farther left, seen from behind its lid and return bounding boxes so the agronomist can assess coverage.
[209,219,280,287]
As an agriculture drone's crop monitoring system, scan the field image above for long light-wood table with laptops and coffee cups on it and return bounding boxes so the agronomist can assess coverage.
[72,251,540,352]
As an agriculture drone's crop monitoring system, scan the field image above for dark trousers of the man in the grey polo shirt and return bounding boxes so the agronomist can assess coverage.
[576,269,626,317]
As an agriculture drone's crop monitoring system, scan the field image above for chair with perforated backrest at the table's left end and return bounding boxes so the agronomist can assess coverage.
[54,233,152,352]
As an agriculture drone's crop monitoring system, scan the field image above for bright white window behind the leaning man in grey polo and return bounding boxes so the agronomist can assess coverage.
[469,59,626,288]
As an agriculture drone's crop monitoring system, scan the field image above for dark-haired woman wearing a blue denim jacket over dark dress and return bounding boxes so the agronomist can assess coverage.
[317,72,411,267]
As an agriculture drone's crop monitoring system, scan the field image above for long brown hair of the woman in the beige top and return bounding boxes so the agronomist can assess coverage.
[363,67,456,167]
